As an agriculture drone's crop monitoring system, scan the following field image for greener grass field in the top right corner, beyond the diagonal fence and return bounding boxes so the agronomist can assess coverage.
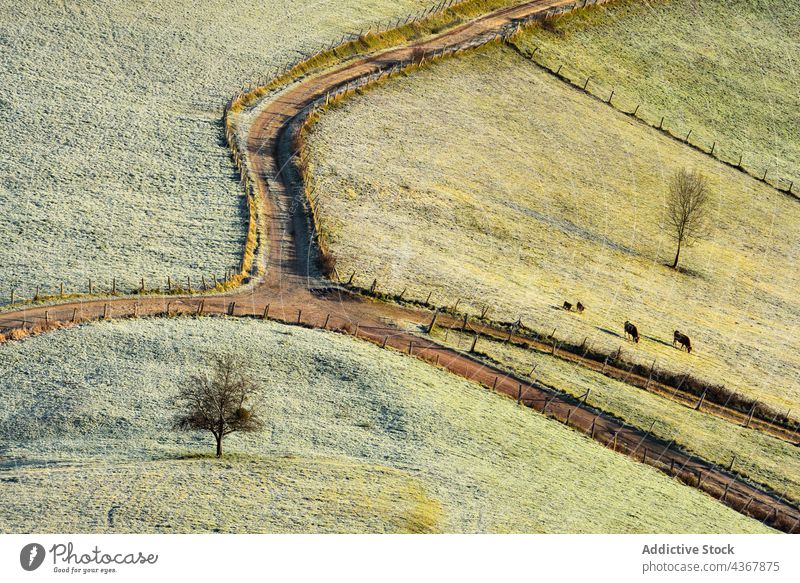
[518,0,800,187]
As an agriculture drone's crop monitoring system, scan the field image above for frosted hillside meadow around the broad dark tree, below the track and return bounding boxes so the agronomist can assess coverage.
[0,319,766,532]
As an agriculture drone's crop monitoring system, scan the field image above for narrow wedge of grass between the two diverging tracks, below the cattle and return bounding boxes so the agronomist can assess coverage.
[436,330,800,500]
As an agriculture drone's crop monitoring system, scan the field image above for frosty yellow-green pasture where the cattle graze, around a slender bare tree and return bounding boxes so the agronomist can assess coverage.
[308,48,800,413]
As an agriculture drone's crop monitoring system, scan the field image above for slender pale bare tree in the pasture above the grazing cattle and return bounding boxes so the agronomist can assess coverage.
[664,168,710,269]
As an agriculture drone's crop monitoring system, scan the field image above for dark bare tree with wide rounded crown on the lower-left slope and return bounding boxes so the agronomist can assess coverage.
[175,354,264,457]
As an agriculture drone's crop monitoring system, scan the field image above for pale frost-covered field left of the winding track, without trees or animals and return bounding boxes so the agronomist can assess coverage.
[0,0,433,302]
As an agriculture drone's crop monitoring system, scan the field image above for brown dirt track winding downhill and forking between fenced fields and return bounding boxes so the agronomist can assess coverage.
[0,0,800,532]
